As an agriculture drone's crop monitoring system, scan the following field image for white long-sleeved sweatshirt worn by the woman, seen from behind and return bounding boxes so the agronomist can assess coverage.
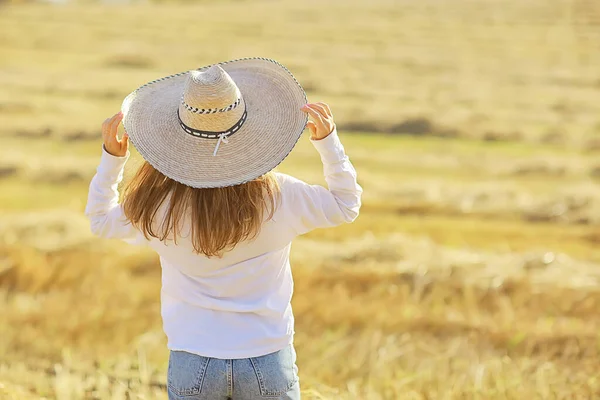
[85,131,362,359]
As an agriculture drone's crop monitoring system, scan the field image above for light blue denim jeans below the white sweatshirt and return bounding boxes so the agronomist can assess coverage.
[167,344,300,400]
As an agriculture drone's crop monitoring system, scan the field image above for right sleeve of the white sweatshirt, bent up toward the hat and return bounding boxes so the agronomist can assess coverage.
[282,130,363,235]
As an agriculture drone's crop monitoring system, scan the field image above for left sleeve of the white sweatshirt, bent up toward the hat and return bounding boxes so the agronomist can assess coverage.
[85,146,146,244]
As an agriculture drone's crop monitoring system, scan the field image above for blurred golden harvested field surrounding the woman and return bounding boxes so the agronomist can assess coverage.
[0,0,600,399]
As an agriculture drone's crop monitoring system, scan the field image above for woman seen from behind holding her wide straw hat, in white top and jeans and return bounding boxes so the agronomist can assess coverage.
[86,58,362,400]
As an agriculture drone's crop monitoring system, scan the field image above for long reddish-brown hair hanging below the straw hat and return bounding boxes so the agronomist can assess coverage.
[123,162,280,257]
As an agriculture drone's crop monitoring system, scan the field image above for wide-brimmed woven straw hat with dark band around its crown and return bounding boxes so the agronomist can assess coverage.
[121,58,307,188]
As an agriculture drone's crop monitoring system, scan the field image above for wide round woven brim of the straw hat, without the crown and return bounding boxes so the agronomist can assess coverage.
[121,58,308,188]
